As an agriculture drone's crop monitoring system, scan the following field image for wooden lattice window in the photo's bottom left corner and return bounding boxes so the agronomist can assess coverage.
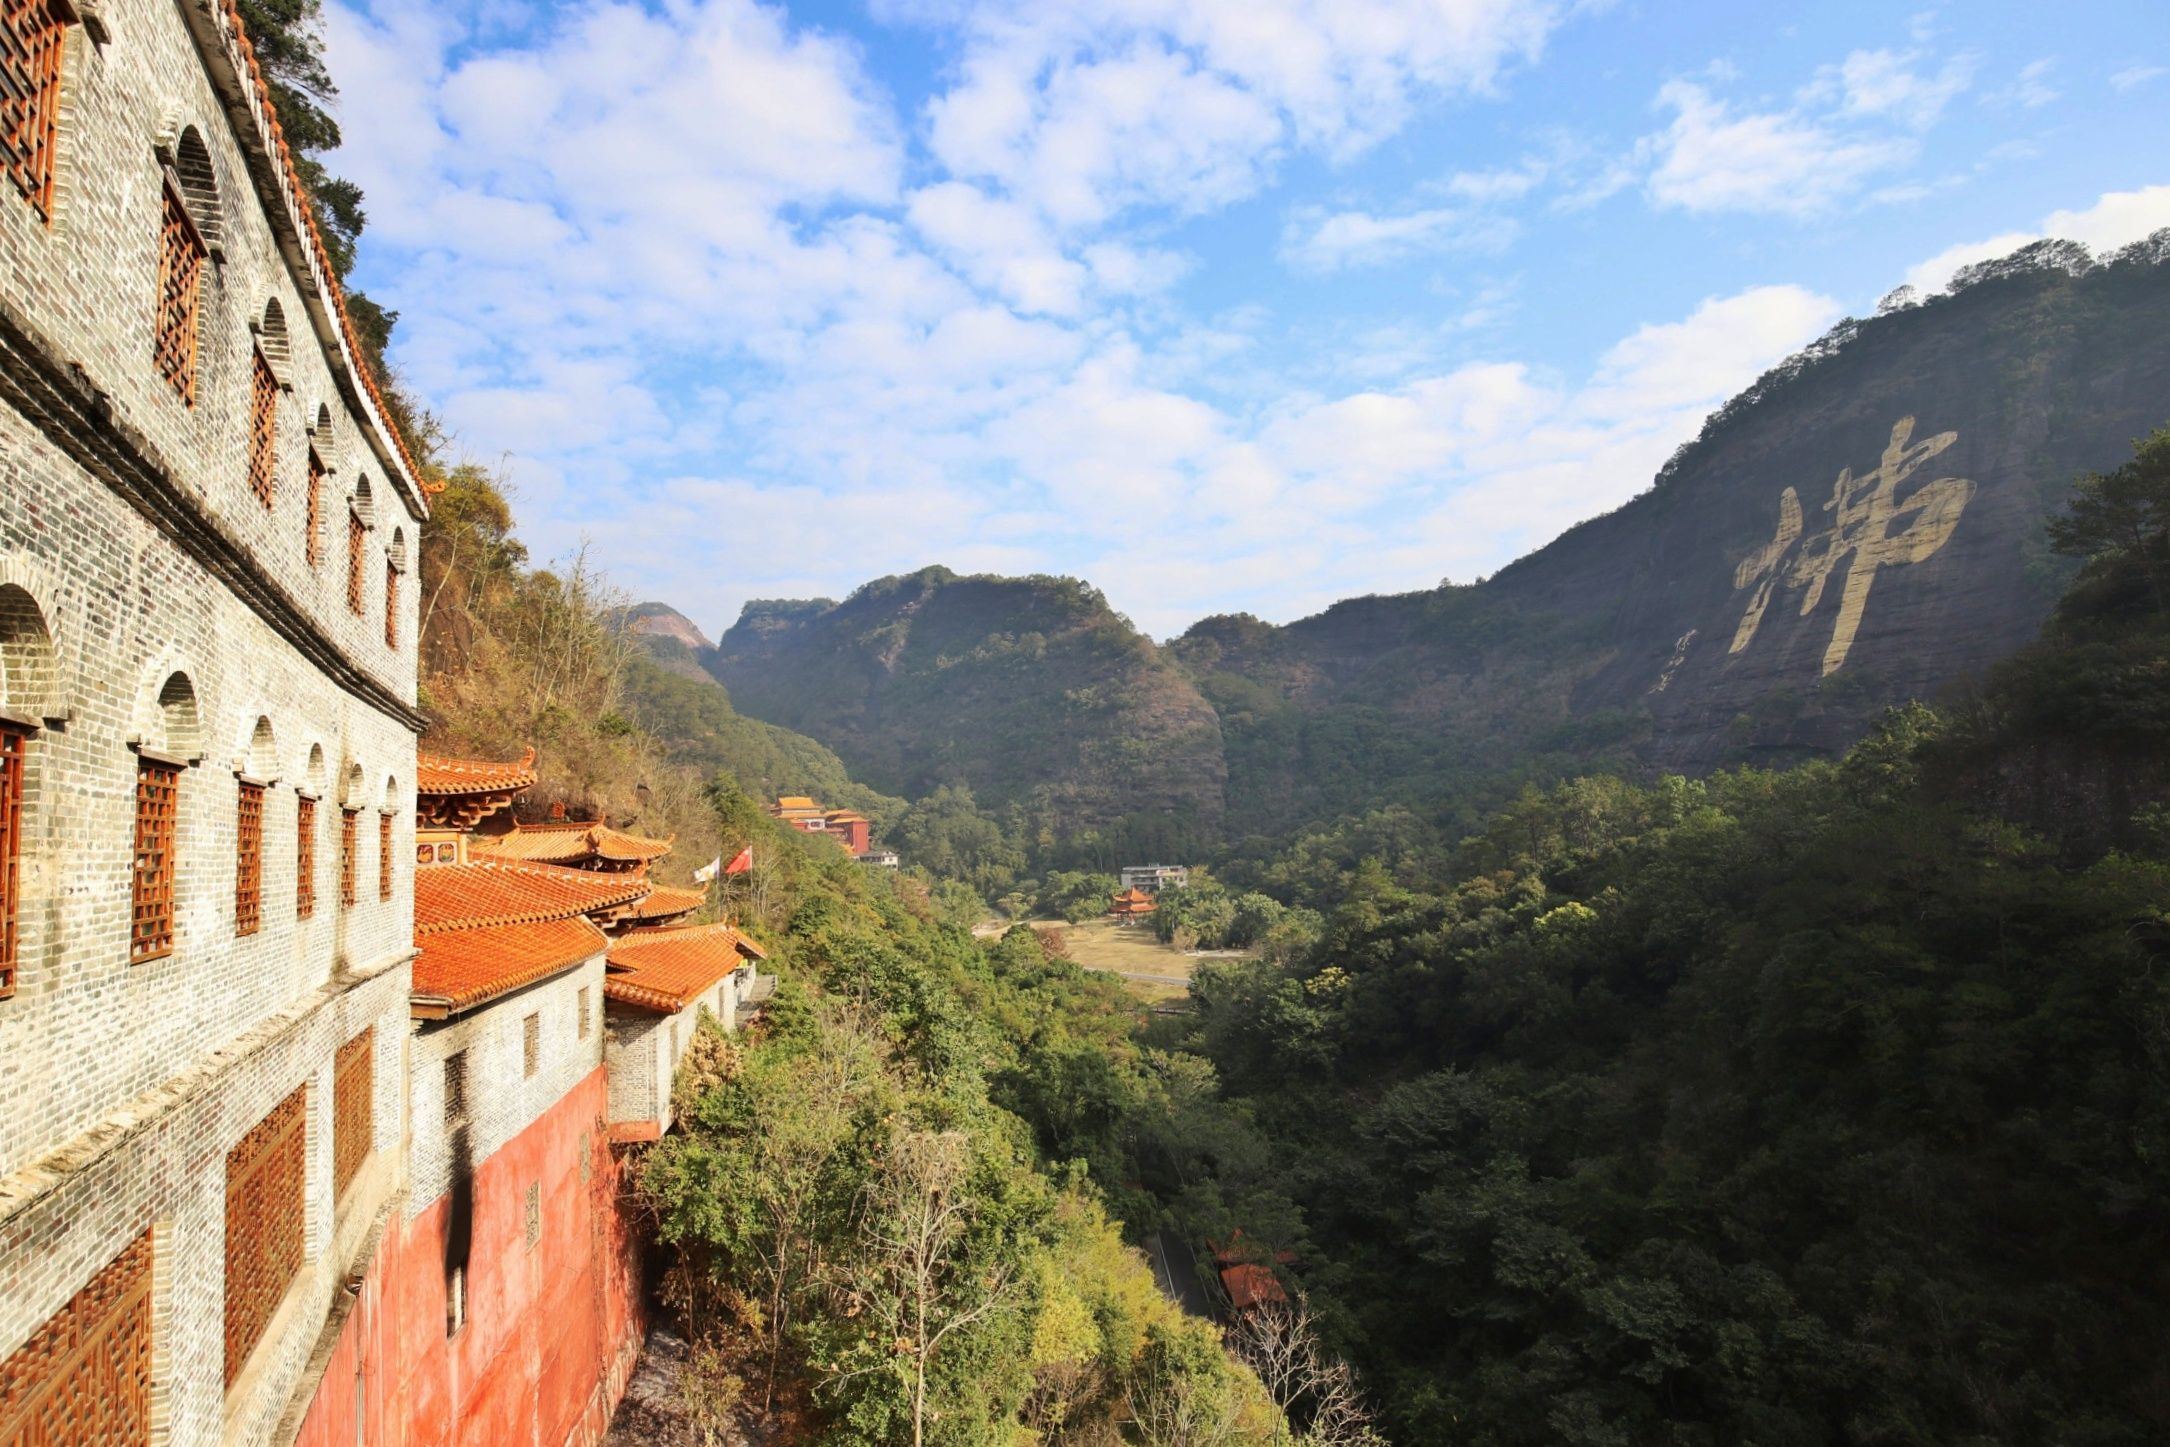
[0,1232,152,1447]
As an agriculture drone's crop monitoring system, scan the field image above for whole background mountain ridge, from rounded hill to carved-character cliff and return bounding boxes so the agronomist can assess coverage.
[692,236,2170,842]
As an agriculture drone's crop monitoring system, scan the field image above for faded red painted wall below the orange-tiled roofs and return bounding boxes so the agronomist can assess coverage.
[295,1070,647,1447]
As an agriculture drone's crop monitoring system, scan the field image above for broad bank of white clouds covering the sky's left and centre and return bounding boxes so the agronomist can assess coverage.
[330,0,1836,633]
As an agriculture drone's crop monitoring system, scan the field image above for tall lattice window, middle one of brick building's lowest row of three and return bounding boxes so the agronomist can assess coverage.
[226,1085,308,1386]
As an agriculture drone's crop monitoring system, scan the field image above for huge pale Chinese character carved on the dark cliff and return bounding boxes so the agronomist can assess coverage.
[1729,417,1975,677]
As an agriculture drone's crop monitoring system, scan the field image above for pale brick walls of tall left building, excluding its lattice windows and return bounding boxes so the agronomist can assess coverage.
[0,0,427,1447]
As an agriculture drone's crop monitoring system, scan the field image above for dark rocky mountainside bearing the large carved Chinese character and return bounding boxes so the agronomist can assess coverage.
[1170,236,2170,829]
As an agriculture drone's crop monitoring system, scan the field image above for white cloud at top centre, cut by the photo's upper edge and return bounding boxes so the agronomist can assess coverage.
[915,0,1565,226]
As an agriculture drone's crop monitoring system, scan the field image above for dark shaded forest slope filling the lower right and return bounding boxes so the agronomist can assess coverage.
[1100,432,2170,1447]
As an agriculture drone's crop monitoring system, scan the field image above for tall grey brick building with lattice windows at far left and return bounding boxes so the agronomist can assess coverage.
[0,0,425,1443]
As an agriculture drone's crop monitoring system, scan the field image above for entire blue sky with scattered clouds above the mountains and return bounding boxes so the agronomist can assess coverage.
[328,0,2170,636]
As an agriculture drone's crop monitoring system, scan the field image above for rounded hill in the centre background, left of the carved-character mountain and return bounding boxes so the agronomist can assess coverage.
[705,568,1226,835]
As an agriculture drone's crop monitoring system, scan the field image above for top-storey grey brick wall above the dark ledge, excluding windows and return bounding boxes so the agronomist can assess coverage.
[0,0,417,701]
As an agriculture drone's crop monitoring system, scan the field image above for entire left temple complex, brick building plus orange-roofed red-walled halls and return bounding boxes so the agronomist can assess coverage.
[0,0,764,1447]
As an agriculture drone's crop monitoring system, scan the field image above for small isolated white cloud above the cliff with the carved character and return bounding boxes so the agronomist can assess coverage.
[1649,80,1914,215]
